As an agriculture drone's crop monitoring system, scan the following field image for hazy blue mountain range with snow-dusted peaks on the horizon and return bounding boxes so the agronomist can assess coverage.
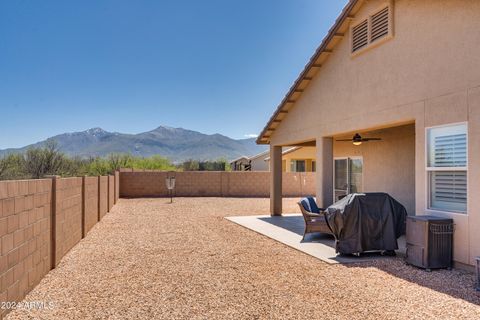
[0,126,266,162]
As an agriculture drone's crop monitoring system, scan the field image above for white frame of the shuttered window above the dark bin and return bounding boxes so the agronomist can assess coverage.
[424,121,470,216]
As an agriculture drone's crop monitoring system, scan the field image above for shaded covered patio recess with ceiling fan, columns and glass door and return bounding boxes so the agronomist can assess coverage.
[270,122,416,216]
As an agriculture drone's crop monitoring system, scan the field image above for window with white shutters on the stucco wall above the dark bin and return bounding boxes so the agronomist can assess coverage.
[427,124,468,213]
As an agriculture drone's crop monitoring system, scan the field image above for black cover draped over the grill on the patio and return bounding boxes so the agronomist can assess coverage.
[326,193,407,254]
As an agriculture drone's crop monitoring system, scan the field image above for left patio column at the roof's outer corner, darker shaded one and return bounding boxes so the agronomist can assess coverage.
[270,145,282,216]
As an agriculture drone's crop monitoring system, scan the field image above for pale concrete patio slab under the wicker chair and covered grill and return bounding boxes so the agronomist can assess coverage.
[225,214,405,264]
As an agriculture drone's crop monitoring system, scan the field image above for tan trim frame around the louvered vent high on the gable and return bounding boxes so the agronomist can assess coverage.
[349,0,394,58]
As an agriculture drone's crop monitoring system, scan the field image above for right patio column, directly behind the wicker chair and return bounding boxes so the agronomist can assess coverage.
[316,137,333,208]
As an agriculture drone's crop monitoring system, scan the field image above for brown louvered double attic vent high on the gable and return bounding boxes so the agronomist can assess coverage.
[351,5,392,53]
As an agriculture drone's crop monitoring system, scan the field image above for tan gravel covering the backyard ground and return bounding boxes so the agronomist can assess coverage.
[7,198,480,320]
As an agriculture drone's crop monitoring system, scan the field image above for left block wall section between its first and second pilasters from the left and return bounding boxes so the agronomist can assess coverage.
[54,178,83,265]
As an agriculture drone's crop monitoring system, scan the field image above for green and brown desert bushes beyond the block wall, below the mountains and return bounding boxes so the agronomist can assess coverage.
[0,140,230,180]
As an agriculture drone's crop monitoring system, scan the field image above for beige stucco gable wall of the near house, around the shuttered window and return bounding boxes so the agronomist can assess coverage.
[271,0,480,264]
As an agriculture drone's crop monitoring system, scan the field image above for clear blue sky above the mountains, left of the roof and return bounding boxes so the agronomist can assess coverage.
[0,0,347,149]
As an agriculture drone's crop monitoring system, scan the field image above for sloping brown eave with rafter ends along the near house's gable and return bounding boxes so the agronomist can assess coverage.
[257,0,364,144]
